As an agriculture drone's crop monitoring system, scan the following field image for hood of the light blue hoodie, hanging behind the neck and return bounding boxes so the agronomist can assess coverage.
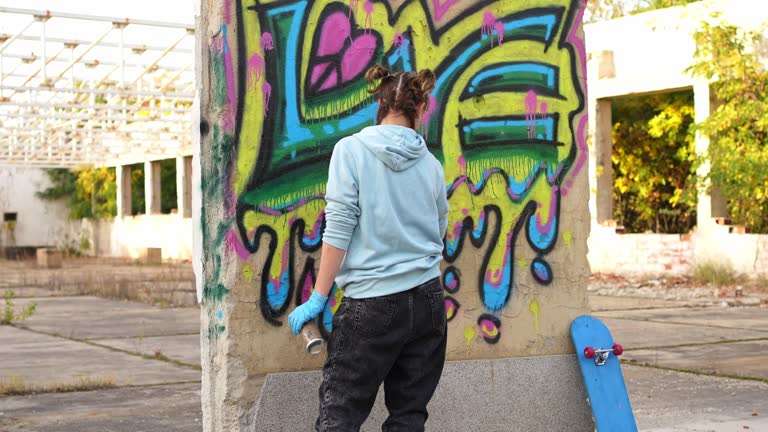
[355,125,427,171]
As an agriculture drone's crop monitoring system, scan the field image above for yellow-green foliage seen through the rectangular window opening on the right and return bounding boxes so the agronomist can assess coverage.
[611,92,696,233]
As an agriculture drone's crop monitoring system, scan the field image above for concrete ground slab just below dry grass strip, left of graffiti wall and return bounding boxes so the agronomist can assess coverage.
[12,296,200,339]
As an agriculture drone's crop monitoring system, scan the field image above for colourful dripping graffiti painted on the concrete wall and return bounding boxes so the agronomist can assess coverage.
[203,0,587,343]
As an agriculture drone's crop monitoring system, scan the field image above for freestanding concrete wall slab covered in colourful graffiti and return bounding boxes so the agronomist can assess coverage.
[197,0,589,431]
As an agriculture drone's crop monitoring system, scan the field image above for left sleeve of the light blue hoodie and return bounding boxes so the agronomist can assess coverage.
[323,141,360,250]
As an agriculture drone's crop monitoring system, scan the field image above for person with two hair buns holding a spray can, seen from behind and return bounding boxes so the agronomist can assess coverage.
[289,66,448,432]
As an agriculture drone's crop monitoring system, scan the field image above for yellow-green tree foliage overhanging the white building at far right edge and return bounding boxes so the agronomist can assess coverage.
[690,22,768,233]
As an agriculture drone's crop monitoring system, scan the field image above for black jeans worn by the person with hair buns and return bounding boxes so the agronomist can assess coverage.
[315,279,447,432]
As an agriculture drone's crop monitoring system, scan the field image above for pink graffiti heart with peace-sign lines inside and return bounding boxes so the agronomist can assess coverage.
[310,12,378,91]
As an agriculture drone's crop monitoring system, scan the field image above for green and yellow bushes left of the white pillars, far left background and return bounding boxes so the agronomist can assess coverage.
[36,168,117,219]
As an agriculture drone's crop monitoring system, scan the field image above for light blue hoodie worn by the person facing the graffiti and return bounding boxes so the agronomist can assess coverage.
[323,125,448,298]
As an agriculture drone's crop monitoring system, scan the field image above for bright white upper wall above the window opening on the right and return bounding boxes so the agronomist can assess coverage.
[584,0,766,99]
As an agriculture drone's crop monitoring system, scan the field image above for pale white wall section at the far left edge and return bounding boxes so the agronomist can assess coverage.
[0,167,68,251]
